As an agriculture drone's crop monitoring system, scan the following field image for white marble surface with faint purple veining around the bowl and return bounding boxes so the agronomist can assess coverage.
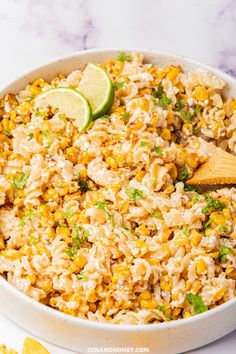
[0,0,236,354]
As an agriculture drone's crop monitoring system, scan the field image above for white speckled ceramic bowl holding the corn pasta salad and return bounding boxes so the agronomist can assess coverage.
[0,50,236,354]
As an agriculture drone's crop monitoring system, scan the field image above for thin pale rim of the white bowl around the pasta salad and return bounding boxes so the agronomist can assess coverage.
[0,47,236,332]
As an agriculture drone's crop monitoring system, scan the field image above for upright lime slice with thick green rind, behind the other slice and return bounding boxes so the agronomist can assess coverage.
[78,63,114,119]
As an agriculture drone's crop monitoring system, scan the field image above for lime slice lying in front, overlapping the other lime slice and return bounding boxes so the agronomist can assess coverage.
[35,87,92,131]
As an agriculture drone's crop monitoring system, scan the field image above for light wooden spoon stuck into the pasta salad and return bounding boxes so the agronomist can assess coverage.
[187,146,236,185]
